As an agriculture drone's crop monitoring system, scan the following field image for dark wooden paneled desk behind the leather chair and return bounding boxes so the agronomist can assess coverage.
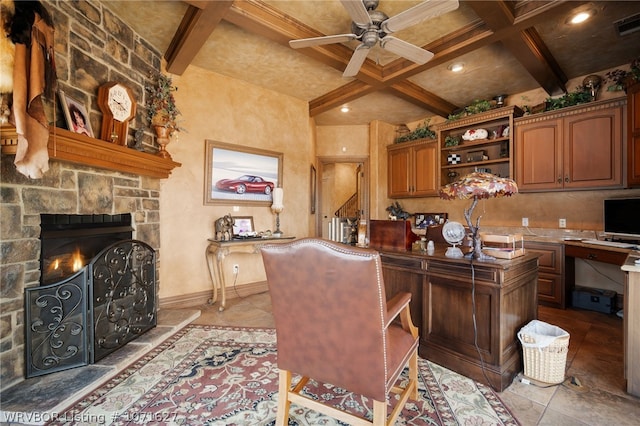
[380,244,538,391]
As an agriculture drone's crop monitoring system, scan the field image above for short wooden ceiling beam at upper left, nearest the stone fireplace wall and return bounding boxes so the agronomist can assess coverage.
[164,0,233,75]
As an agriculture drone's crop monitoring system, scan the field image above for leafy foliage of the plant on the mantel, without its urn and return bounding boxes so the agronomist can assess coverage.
[145,73,185,135]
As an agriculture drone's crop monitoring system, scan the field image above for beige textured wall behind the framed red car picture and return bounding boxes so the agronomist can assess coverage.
[160,67,314,299]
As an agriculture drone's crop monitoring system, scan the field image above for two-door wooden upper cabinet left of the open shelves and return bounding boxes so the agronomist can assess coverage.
[387,139,439,198]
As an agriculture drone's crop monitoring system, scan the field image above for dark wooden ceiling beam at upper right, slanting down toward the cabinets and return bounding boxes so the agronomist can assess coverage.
[469,0,567,95]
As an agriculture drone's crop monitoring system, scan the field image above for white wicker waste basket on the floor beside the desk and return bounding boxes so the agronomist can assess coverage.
[518,320,569,384]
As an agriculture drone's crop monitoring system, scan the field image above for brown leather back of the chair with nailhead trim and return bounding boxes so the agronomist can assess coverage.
[262,238,394,401]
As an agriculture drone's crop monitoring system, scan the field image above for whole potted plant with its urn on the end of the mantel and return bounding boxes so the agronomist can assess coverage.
[145,73,184,159]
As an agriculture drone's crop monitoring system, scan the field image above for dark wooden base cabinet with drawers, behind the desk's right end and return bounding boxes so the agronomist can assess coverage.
[524,241,569,309]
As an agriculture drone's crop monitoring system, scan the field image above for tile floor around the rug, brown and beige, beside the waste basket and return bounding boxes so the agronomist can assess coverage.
[194,293,640,426]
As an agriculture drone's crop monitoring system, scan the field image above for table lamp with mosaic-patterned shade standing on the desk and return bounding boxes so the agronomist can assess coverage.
[438,172,518,260]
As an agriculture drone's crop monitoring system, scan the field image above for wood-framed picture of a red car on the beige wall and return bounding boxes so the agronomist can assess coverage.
[204,140,283,206]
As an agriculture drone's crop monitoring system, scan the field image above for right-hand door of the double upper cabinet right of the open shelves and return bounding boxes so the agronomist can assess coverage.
[563,107,622,188]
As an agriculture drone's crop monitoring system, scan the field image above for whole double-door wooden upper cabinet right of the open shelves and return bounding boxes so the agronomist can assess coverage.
[514,98,626,192]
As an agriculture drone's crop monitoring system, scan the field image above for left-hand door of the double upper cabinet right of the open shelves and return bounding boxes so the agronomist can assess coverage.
[515,120,562,191]
